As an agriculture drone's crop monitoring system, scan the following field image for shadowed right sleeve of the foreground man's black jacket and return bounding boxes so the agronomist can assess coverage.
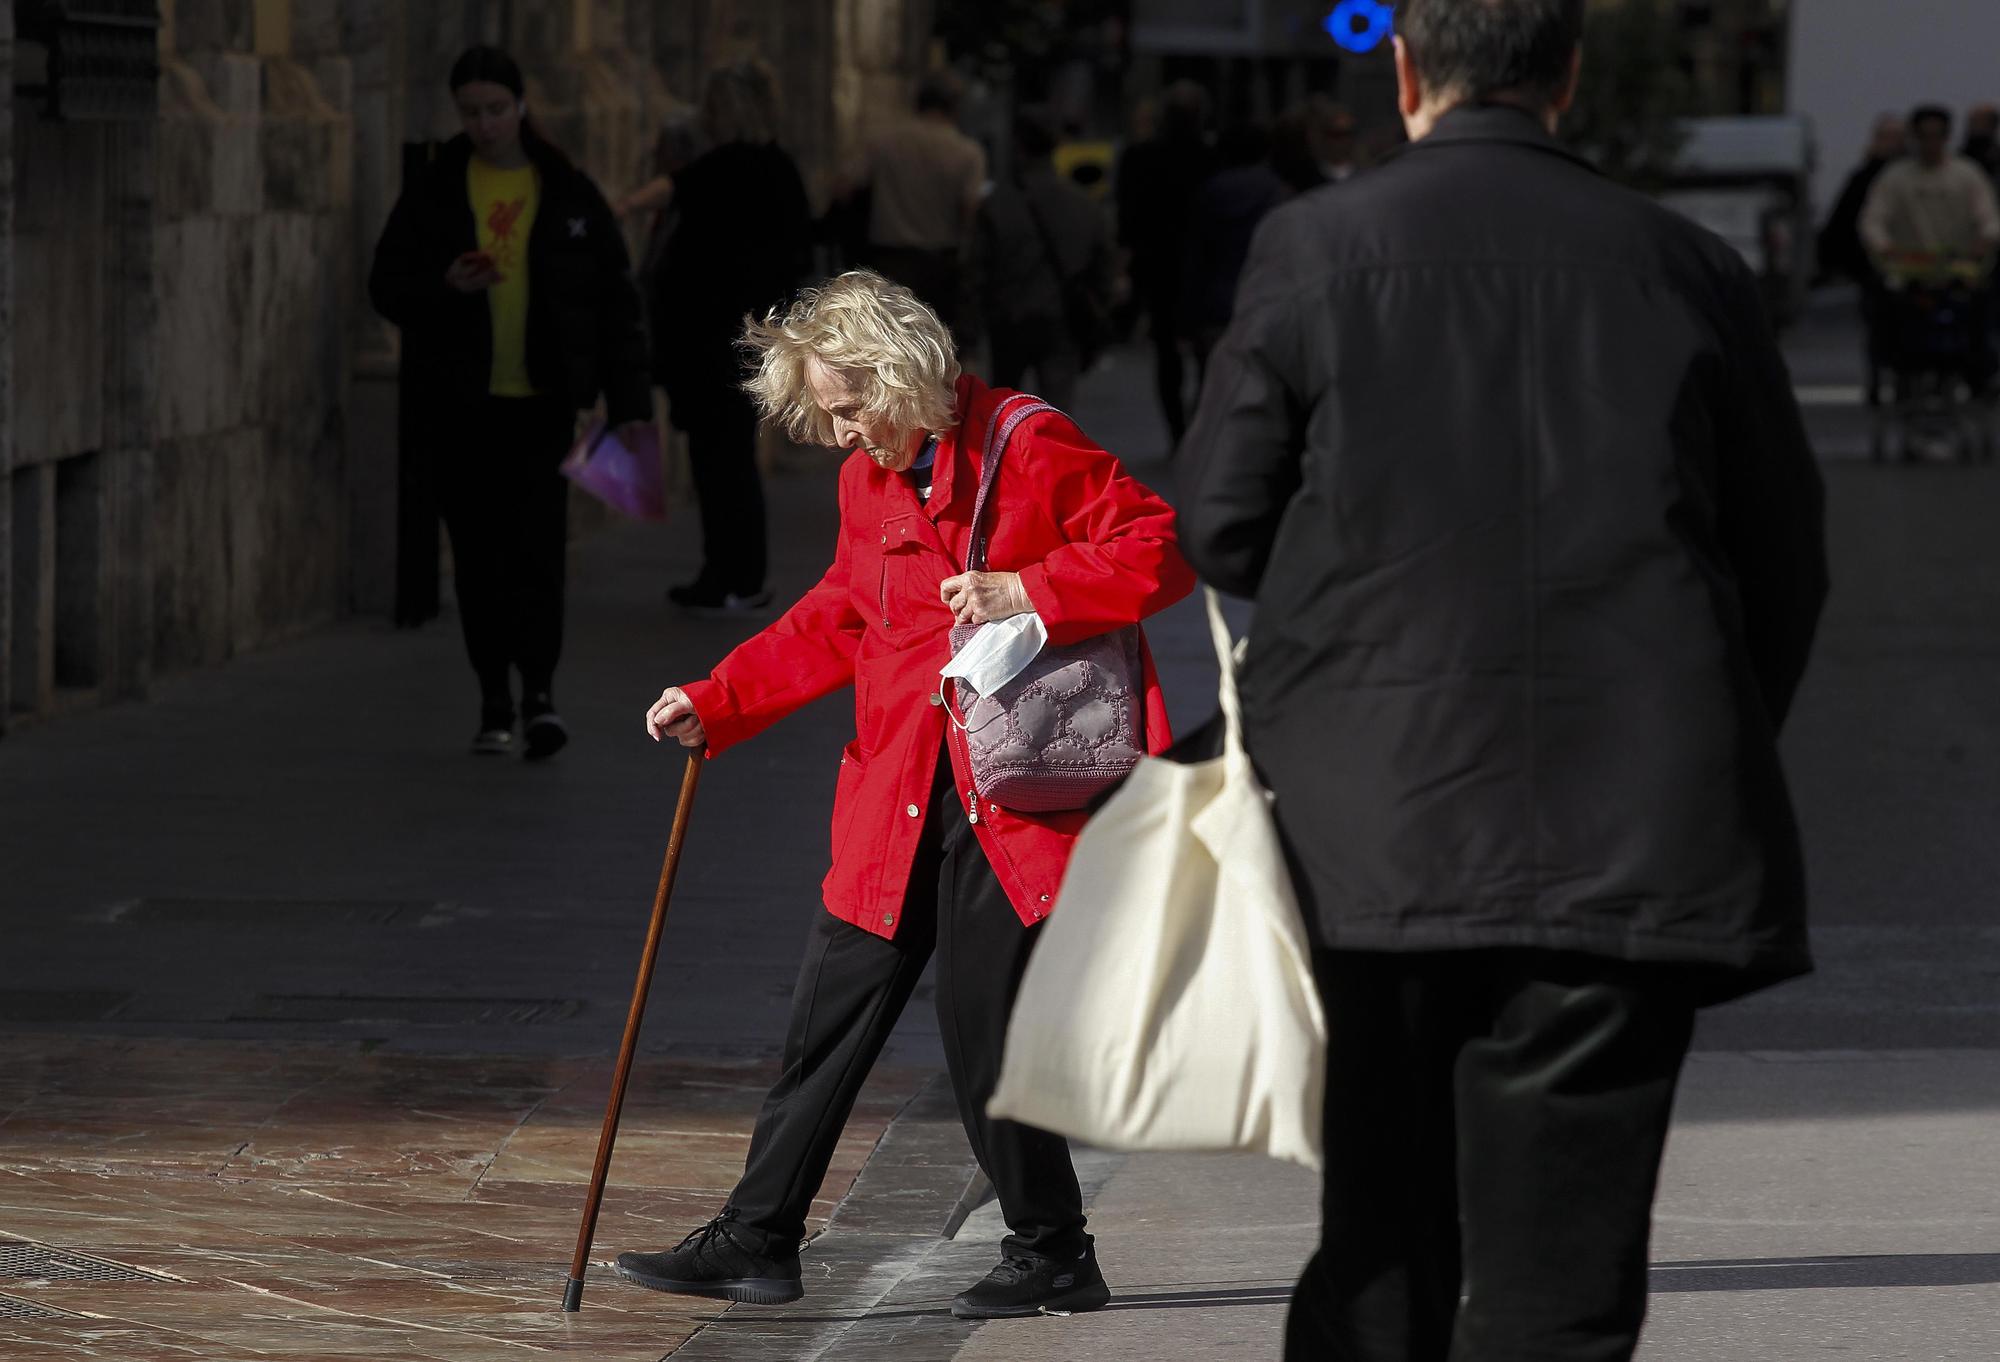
[1716,260,1828,724]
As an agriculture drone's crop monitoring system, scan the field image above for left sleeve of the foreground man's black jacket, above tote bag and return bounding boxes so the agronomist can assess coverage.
[1176,208,1306,596]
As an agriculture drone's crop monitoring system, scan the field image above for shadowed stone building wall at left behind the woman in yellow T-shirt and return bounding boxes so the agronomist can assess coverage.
[0,0,930,728]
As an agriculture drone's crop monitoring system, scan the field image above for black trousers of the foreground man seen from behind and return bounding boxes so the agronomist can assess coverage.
[1284,950,1694,1362]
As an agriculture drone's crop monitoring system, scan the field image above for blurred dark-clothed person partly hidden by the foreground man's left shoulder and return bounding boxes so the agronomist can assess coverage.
[1180,120,1288,378]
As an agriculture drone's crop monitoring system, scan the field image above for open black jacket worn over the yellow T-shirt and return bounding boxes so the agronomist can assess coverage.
[368,136,652,424]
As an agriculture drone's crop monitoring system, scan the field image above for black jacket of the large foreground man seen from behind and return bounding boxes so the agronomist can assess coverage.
[1180,108,1826,996]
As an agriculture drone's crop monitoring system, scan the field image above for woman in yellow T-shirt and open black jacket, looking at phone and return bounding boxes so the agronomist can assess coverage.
[368,48,652,758]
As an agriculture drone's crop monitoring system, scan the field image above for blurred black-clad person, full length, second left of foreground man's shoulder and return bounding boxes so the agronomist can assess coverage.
[1116,80,1216,444]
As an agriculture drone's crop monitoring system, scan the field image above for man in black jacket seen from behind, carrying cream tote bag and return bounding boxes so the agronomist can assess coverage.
[1180,0,1826,1362]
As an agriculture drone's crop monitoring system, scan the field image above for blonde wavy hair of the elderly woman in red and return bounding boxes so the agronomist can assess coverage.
[742,270,958,446]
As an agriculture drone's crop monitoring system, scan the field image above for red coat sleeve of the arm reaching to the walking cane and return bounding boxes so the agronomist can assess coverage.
[684,462,866,756]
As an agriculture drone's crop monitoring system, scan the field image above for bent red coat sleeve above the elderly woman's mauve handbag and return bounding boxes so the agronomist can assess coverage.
[1008,414,1194,644]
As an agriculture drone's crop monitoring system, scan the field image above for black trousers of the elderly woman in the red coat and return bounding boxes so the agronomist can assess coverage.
[730,756,1090,1258]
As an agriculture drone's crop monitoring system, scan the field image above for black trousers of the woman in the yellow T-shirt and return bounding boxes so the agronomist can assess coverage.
[438,398,576,718]
